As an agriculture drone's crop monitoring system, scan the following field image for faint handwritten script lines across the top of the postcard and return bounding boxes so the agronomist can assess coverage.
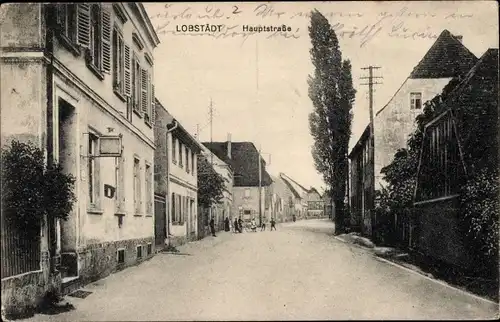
[150,3,473,47]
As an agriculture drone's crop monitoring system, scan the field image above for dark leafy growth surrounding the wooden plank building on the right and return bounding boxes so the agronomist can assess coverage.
[380,61,500,263]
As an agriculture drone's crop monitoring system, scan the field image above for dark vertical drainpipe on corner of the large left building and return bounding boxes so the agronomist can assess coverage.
[45,4,57,273]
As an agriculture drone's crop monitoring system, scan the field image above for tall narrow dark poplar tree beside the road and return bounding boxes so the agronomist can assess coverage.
[308,10,356,233]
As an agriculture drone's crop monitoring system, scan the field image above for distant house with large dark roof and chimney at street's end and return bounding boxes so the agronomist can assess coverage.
[203,140,272,225]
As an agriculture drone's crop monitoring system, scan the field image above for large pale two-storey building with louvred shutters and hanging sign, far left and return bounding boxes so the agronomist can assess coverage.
[2,3,159,314]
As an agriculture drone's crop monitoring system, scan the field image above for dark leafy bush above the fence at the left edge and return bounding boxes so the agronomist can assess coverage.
[2,141,76,230]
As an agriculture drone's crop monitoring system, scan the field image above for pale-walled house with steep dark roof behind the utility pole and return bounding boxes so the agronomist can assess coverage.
[349,30,478,235]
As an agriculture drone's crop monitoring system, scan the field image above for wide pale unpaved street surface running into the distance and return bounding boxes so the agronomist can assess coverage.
[24,220,498,321]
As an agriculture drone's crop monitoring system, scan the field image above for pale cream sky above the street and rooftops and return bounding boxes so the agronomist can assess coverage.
[144,1,498,191]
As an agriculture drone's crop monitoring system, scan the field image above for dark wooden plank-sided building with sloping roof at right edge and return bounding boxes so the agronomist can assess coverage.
[410,49,498,268]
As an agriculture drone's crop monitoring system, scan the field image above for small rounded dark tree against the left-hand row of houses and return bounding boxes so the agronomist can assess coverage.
[197,154,225,207]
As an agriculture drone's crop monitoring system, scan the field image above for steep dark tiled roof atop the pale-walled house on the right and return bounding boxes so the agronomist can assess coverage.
[410,30,478,78]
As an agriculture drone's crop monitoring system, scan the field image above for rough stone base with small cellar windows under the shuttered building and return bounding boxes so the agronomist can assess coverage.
[78,237,155,285]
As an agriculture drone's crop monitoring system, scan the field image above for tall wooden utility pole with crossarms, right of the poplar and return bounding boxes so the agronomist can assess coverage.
[361,66,383,231]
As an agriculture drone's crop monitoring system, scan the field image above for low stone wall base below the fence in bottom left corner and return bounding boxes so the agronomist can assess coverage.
[2,252,61,318]
